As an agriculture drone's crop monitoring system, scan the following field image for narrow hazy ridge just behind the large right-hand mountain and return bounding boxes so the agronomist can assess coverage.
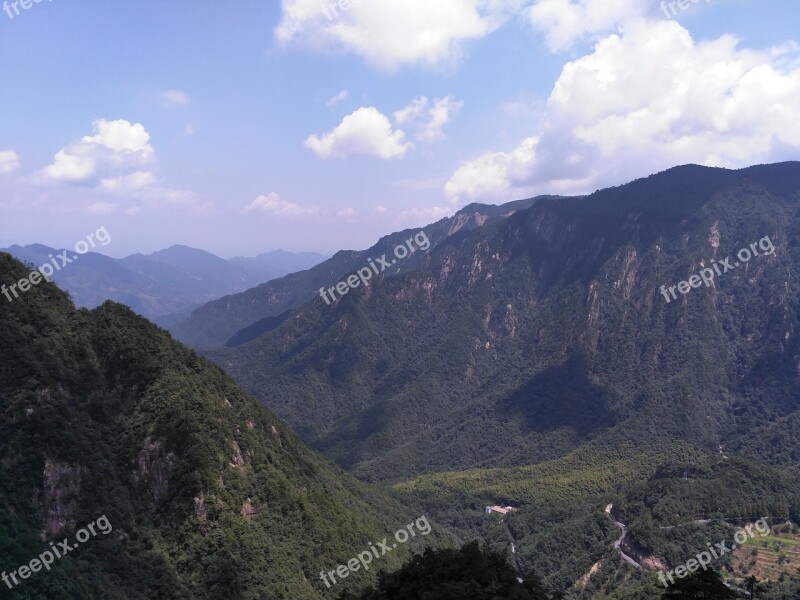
[169,196,555,348]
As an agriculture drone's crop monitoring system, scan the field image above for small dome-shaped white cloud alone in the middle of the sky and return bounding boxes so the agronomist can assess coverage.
[305,107,412,159]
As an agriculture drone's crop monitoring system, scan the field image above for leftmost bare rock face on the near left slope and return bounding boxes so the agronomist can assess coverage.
[42,458,81,539]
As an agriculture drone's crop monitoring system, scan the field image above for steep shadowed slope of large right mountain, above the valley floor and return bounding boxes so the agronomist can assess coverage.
[205,163,800,478]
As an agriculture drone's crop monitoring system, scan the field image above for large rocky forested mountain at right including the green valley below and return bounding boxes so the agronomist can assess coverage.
[195,162,800,599]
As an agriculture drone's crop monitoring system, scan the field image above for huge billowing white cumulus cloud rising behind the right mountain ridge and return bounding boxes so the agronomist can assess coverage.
[445,19,800,202]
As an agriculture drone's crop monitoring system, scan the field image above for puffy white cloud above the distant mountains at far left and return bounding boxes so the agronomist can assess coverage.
[44,119,154,183]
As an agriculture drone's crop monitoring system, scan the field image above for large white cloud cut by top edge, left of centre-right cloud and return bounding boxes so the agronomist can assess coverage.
[275,0,528,70]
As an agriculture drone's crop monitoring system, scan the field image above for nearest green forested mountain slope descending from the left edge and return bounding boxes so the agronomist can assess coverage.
[0,253,432,600]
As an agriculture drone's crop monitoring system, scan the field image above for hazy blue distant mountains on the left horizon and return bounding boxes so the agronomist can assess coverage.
[0,244,325,324]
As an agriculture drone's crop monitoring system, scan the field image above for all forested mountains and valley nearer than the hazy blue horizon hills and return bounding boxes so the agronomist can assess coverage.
[0,162,800,600]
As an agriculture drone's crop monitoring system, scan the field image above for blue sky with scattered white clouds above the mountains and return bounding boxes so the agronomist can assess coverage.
[0,0,800,257]
